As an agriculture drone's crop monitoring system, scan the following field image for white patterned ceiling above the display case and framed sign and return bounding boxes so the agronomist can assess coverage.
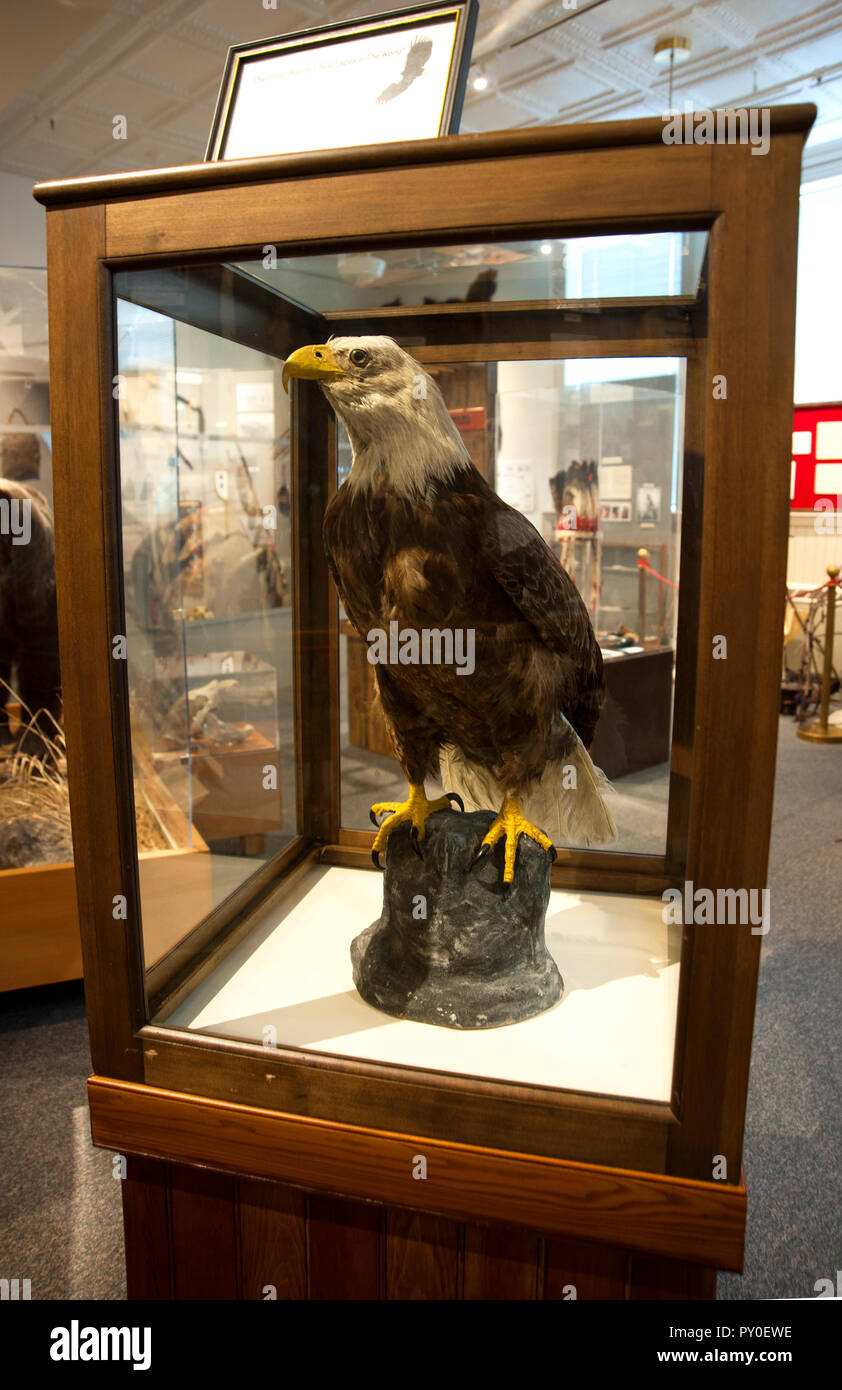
[0,0,842,179]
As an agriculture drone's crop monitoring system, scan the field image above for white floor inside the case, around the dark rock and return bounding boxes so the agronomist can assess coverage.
[167,866,681,1101]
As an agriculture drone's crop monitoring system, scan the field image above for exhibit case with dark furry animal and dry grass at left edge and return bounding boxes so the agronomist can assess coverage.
[0,265,71,990]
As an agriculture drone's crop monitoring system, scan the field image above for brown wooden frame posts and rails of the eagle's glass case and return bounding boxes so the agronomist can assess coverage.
[36,106,816,1245]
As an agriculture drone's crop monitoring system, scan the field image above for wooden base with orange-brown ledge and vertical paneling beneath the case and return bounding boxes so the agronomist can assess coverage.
[89,1077,745,1300]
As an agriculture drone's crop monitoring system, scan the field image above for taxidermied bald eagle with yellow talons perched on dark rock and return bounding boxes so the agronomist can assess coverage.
[283,338,616,883]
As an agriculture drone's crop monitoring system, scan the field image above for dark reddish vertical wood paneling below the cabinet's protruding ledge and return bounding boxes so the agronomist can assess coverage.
[122,1158,716,1301]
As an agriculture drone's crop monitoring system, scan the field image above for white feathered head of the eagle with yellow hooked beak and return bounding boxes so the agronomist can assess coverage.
[283,336,472,496]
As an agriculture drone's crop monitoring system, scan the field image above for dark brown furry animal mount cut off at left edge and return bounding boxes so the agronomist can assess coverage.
[0,478,61,755]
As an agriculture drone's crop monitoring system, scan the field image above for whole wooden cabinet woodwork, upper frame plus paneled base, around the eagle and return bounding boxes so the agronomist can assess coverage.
[36,106,814,1298]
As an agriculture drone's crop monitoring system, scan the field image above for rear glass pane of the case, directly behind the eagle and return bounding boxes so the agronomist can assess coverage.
[339,357,685,855]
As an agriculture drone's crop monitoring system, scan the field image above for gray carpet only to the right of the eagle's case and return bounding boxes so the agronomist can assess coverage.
[718,719,842,1298]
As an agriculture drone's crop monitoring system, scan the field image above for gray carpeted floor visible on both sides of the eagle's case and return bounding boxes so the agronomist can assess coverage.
[0,720,842,1300]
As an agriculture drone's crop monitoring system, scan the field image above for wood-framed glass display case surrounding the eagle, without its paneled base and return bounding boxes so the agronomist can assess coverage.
[38,107,811,1289]
